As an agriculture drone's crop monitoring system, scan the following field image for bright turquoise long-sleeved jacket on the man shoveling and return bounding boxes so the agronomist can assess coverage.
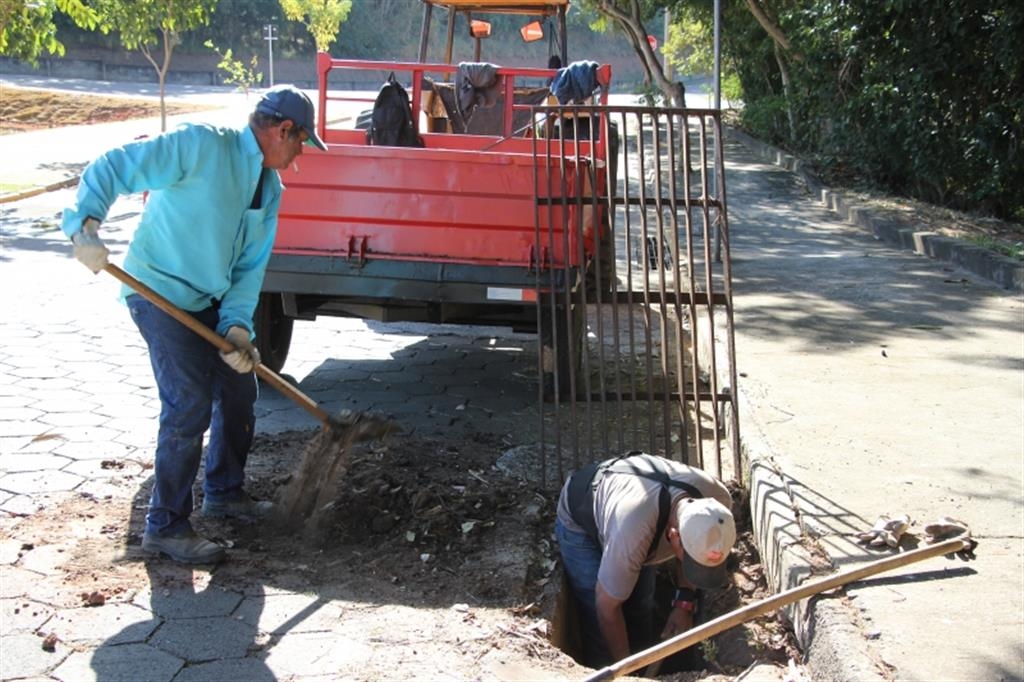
[61,124,282,335]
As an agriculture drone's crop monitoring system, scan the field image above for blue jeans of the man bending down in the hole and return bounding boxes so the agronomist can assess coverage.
[555,519,656,668]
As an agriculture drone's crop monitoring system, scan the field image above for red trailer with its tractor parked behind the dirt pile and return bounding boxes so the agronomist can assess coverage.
[256,0,614,387]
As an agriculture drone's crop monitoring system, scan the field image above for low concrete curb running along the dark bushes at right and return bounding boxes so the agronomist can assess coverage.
[726,128,1024,292]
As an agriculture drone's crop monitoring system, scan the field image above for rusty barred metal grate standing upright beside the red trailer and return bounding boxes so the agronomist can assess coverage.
[534,100,740,483]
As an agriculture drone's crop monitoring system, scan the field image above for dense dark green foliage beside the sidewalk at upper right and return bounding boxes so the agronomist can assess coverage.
[669,0,1024,221]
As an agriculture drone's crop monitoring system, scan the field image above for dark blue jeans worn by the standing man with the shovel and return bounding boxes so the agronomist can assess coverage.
[127,295,257,536]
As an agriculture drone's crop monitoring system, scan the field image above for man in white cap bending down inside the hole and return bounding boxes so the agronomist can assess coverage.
[555,453,736,668]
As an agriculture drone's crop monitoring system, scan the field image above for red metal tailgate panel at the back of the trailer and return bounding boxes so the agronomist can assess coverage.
[274,143,589,267]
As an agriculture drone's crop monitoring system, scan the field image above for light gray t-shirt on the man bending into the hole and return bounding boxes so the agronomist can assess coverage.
[558,455,732,600]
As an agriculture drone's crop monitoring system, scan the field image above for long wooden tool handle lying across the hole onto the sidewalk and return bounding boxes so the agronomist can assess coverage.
[584,538,971,682]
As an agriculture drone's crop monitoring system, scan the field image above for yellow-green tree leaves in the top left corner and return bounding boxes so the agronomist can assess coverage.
[0,0,105,63]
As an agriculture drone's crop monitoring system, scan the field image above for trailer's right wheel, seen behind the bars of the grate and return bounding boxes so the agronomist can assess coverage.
[541,296,587,399]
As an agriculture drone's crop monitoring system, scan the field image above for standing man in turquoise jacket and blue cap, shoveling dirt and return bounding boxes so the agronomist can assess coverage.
[61,86,327,563]
